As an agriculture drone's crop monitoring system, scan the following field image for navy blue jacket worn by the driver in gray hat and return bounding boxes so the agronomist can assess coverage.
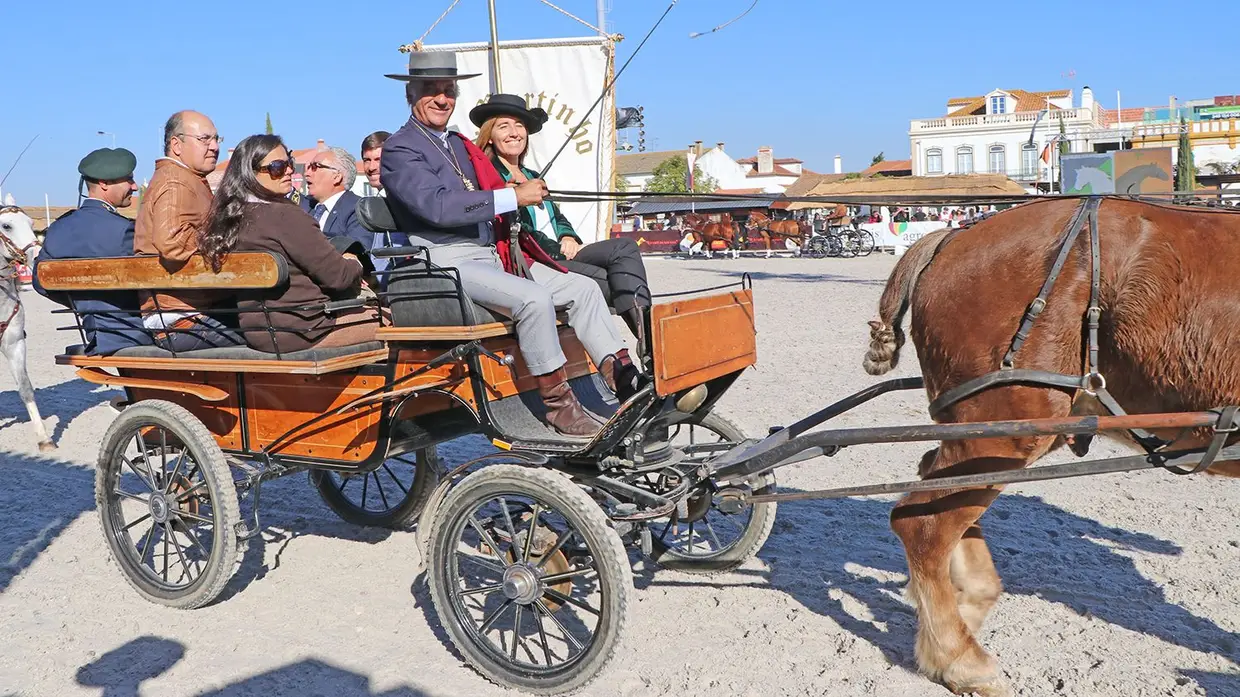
[379,117,495,247]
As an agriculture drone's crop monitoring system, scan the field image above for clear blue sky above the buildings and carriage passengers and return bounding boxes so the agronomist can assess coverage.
[0,0,1240,206]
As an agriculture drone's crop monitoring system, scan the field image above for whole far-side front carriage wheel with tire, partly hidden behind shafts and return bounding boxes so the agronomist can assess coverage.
[650,413,776,574]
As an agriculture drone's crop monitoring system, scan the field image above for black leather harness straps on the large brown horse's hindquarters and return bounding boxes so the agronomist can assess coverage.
[928,196,1240,474]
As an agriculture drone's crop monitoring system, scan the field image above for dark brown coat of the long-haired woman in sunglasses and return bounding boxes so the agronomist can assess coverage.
[236,200,362,352]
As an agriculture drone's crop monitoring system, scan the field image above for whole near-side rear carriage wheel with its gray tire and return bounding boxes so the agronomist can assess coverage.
[94,399,241,609]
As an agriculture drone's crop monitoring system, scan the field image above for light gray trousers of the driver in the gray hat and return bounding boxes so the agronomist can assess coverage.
[430,244,625,375]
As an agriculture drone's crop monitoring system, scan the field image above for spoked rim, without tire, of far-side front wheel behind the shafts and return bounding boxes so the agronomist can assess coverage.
[650,416,754,559]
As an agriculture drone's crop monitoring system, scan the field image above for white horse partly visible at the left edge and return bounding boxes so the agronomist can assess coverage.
[0,203,56,451]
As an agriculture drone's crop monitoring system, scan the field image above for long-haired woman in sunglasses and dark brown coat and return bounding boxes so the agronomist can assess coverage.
[198,135,378,352]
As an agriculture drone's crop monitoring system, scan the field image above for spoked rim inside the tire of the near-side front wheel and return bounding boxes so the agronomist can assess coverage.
[439,494,608,677]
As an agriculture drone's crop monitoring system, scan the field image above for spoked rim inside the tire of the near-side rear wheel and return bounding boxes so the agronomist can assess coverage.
[105,424,218,593]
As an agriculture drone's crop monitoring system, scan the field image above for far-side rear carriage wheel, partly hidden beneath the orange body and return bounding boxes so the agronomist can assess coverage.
[310,445,439,528]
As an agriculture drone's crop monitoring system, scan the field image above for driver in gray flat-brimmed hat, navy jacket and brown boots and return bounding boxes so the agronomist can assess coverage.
[379,51,625,437]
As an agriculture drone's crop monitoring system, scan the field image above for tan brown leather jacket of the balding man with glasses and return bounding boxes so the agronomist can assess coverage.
[134,158,213,313]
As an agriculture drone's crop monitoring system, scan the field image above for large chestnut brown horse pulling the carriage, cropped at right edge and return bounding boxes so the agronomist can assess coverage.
[864,198,1240,697]
